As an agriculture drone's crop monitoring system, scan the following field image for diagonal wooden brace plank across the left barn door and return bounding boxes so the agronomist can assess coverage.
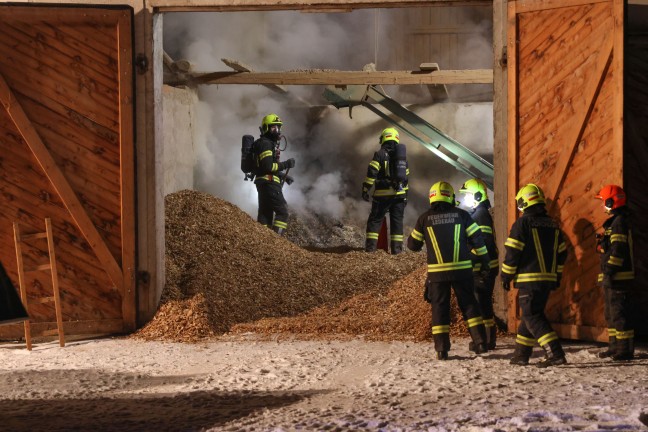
[0,74,123,292]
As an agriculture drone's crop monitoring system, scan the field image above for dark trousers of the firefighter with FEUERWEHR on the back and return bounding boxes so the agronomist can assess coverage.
[425,277,486,352]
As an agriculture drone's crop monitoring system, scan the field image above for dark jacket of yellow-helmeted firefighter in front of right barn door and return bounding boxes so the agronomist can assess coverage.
[501,204,567,290]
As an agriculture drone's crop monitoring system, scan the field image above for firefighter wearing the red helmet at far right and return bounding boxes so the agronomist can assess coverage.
[596,185,634,360]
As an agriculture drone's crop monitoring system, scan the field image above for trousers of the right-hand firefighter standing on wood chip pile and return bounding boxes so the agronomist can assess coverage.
[367,196,407,250]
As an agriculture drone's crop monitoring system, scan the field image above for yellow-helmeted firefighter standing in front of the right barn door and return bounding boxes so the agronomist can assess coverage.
[501,183,567,368]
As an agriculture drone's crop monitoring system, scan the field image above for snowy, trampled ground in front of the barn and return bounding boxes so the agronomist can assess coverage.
[0,337,648,431]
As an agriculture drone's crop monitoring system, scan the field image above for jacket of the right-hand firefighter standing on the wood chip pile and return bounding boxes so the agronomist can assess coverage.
[362,141,409,198]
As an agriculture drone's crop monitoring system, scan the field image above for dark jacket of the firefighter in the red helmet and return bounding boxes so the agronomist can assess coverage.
[597,206,634,282]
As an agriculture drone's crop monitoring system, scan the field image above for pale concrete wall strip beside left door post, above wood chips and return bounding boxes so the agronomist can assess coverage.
[162,86,198,196]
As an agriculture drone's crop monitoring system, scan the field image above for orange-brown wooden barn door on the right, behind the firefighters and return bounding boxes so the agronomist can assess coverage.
[507,0,623,340]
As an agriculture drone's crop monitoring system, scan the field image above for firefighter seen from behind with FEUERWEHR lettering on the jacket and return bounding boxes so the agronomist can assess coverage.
[407,181,490,360]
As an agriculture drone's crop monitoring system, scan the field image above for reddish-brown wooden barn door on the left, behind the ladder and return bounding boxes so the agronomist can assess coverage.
[0,6,136,337]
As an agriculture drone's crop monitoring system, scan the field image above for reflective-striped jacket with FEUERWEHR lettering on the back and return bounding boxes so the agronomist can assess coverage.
[407,202,489,282]
